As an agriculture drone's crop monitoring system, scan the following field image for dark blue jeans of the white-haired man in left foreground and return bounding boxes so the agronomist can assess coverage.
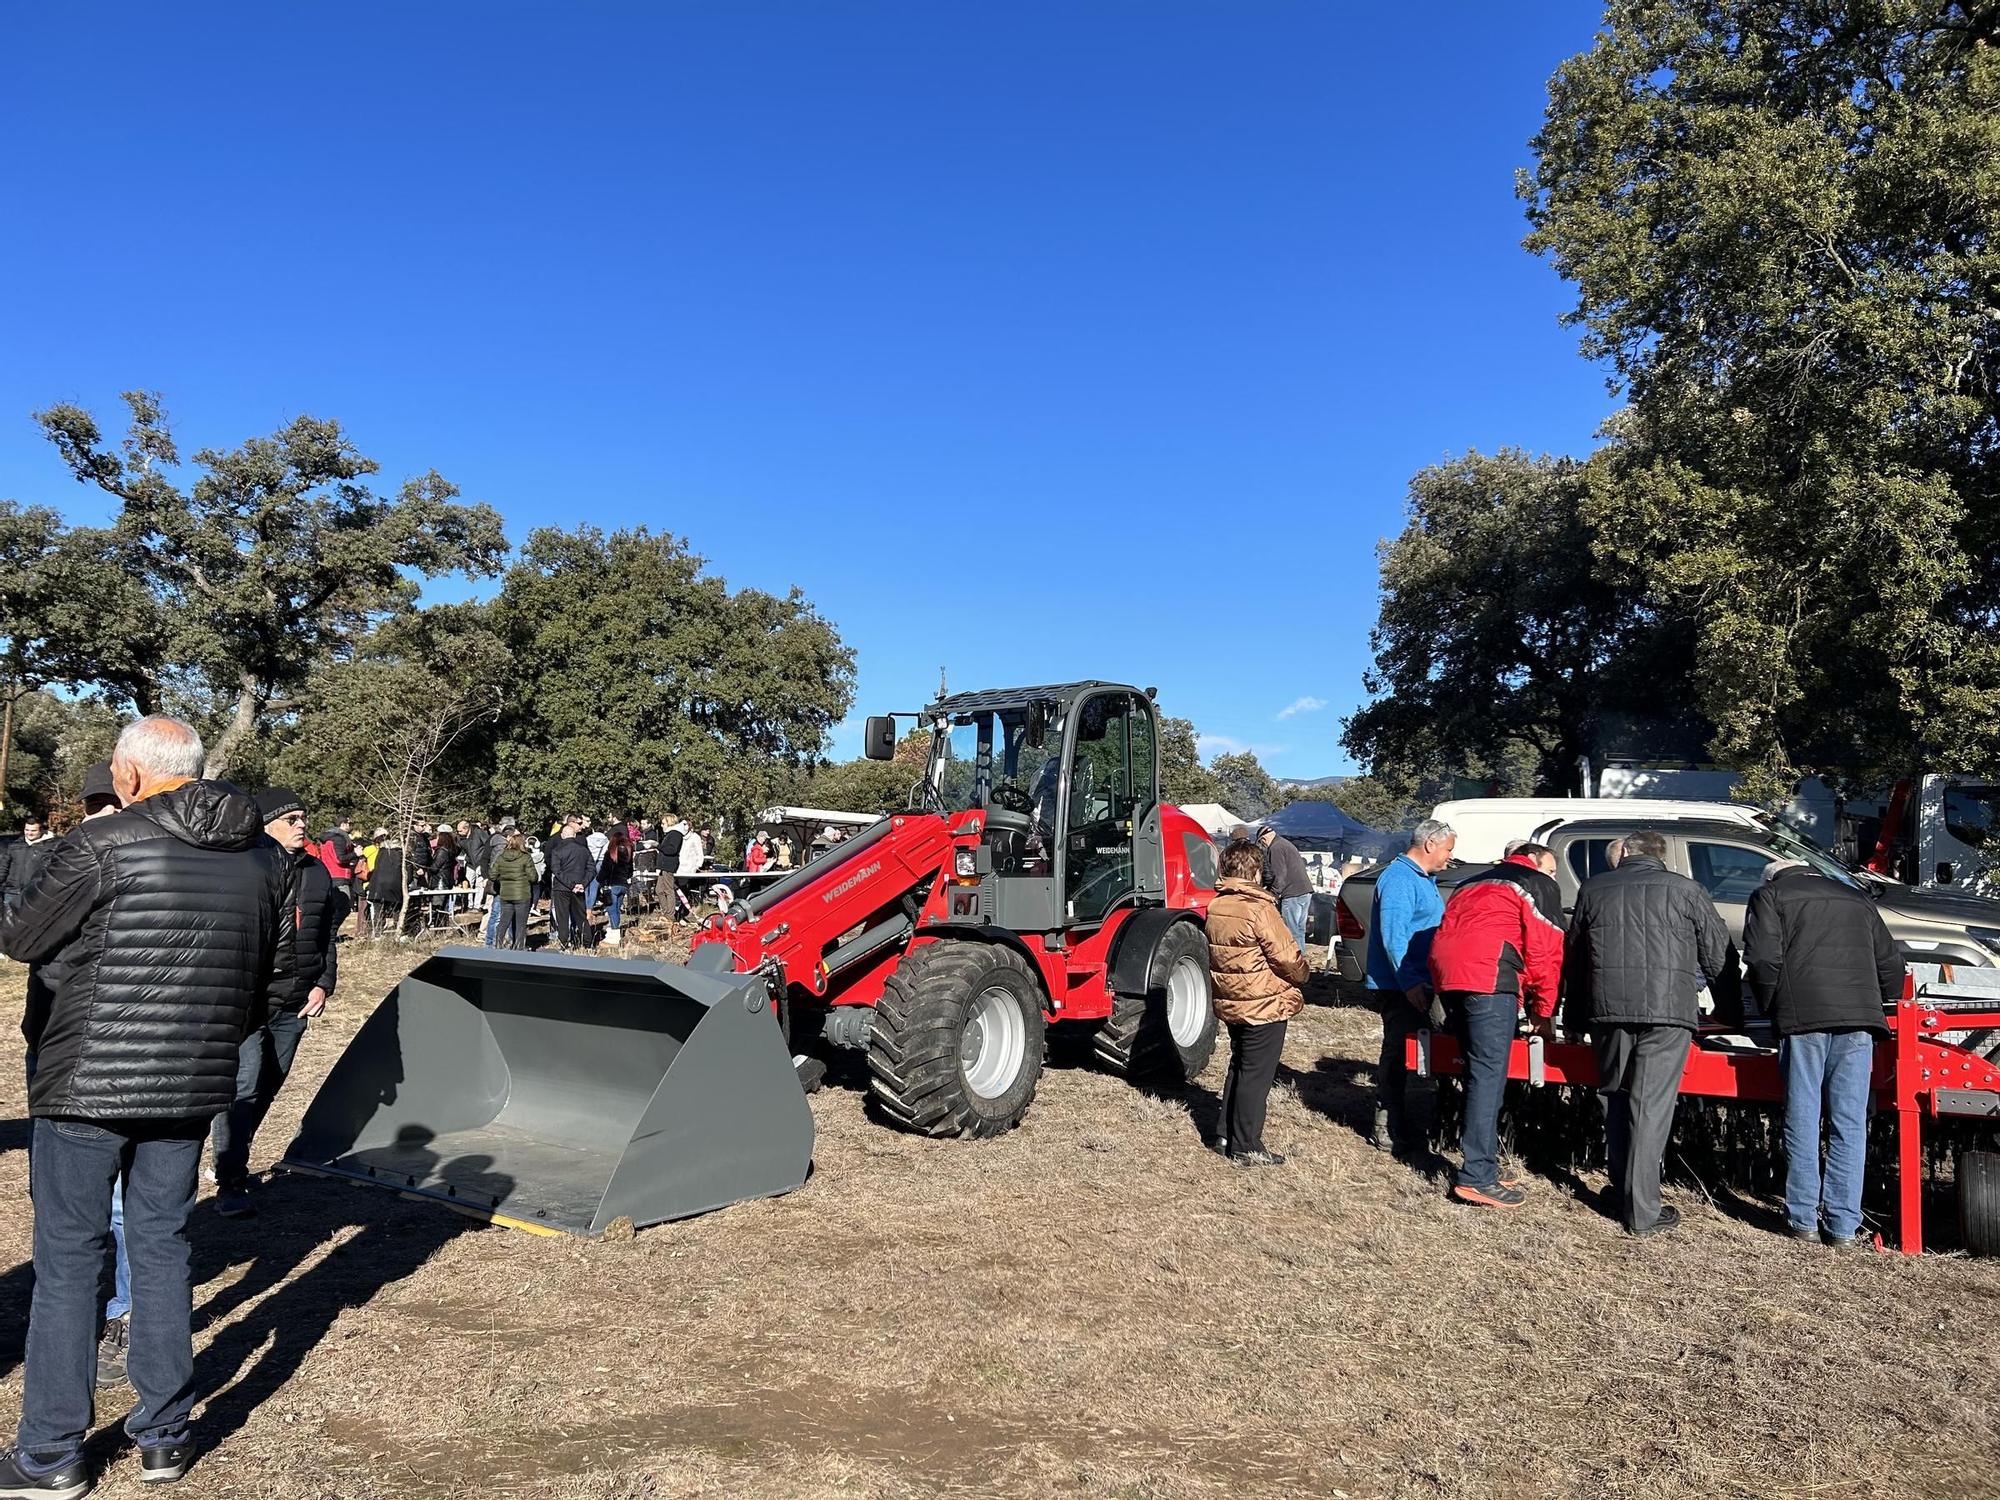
[16,1120,206,1462]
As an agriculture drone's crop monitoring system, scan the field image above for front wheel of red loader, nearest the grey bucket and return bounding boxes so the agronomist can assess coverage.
[868,940,1048,1138]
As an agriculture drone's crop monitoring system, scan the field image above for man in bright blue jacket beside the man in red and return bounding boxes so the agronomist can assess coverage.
[1368,818,1458,1154]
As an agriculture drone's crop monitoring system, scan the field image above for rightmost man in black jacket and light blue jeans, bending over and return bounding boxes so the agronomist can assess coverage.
[1744,860,1904,1248]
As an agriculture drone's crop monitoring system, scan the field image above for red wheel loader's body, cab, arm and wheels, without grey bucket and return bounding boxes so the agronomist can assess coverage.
[696,682,1216,1136]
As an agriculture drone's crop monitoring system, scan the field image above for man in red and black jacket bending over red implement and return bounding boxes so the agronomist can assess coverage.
[1430,844,1562,1208]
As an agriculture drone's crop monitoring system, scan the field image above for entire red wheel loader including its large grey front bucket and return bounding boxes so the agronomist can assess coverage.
[284,682,1216,1234]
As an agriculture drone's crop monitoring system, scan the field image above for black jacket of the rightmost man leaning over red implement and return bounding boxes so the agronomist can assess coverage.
[1744,870,1904,1036]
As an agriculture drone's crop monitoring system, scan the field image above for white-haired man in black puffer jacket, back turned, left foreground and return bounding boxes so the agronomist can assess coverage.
[0,718,286,1496]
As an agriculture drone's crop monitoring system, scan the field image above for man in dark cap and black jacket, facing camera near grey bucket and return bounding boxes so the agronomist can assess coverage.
[212,786,348,1218]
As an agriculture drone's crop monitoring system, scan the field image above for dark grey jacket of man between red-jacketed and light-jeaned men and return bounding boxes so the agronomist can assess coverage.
[1562,856,1742,1032]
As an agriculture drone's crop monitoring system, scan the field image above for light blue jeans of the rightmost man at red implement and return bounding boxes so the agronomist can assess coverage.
[1778,1032,1874,1240]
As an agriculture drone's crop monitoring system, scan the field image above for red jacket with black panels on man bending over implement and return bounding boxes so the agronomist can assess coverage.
[1430,854,1562,1016]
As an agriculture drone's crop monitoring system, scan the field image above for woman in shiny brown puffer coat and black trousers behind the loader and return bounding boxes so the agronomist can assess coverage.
[1208,842,1306,1166]
